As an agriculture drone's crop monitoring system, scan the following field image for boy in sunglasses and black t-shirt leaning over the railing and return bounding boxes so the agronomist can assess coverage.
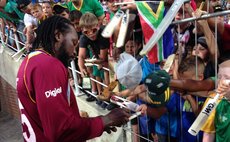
[78,13,109,107]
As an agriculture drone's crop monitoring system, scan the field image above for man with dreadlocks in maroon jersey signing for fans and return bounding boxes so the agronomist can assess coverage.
[17,16,129,142]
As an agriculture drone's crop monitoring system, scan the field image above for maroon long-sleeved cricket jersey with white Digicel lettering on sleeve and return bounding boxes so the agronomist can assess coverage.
[17,51,104,142]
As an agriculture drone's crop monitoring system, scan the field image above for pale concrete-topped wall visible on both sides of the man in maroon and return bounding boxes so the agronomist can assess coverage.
[0,49,131,142]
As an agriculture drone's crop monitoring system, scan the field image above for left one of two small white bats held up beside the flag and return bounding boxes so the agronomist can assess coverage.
[101,10,124,38]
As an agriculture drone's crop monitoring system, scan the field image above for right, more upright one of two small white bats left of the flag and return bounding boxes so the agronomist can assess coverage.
[116,9,129,48]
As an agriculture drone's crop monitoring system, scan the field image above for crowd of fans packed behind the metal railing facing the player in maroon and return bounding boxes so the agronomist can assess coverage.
[0,0,230,142]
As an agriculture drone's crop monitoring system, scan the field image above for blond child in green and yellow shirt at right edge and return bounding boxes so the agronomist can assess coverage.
[202,60,230,142]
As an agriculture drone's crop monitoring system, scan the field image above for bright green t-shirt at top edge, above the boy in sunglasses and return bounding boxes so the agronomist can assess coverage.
[67,0,104,17]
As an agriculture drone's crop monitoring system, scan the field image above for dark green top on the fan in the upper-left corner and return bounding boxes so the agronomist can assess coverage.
[4,1,25,20]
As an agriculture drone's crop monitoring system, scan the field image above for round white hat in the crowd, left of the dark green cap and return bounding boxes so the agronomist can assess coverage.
[115,53,142,89]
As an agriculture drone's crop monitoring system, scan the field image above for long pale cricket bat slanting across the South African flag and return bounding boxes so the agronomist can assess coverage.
[140,0,186,55]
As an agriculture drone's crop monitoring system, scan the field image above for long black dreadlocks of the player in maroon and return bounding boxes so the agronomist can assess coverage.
[32,16,72,55]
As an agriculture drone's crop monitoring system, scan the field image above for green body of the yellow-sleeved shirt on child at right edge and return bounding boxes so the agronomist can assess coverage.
[214,99,230,142]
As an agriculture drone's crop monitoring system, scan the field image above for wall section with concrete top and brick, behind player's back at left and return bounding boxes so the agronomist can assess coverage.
[0,49,20,119]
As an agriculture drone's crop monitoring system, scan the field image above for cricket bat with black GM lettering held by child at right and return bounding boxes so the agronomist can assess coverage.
[188,80,230,136]
